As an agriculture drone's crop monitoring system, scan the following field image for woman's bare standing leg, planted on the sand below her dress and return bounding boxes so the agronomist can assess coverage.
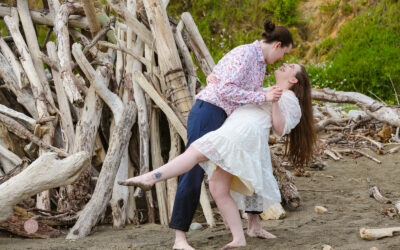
[209,168,246,249]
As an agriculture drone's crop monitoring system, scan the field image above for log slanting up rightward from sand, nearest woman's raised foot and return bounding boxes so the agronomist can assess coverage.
[67,102,137,239]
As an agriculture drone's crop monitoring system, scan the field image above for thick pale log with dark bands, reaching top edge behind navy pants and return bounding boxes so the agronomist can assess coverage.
[144,0,192,120]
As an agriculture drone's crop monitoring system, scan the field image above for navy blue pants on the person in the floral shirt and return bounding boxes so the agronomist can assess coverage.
[169,100,227,232]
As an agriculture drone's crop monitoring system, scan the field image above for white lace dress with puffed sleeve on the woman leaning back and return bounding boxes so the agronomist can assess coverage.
[192,91,301,211]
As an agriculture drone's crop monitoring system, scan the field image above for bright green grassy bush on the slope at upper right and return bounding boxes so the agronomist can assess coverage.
[307,1,400,103]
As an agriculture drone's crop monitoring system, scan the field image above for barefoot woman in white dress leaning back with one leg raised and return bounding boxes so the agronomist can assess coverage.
[120,64,315,249]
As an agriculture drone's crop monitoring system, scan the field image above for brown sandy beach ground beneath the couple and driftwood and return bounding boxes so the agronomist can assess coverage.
[0,153,400,250]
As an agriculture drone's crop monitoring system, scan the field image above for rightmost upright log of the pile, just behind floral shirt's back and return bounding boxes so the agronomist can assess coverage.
[181,12,215,76]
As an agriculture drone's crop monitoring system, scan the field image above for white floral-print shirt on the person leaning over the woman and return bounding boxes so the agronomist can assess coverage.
[196,41,266,115]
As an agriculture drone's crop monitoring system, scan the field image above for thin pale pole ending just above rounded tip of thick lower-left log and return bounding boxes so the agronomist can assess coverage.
[46,42,75,153]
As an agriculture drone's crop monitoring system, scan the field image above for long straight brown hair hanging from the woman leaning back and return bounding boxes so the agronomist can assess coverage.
[286,65,316,167]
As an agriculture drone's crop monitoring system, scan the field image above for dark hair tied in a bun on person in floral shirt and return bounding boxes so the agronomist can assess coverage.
[261,20,293,47]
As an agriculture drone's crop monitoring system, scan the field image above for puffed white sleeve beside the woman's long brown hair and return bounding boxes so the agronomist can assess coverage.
[272,92,301,139]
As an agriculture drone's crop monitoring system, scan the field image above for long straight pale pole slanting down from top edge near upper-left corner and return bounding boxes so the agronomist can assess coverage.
[17,0,55,113]
